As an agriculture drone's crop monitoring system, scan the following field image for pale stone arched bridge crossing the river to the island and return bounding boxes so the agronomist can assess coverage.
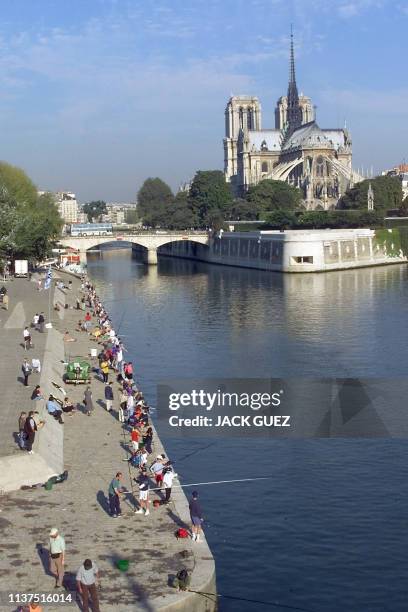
[60,231,209,265]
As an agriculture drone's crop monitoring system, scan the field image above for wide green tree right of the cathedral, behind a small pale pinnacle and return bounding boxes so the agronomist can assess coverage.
[338,176,402,211]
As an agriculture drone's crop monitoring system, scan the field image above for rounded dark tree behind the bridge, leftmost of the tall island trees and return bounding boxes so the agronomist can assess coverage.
[137,178,174,227]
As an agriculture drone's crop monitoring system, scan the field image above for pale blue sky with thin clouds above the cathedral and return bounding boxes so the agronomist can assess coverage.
[0,0,408,202]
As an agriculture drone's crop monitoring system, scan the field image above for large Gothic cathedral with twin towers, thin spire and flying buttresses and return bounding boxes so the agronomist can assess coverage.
[224,34,363,210]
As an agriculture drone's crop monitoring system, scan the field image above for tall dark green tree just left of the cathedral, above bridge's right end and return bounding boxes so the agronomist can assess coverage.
[188,170,232,229]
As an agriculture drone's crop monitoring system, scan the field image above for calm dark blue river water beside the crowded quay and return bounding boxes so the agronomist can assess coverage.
[88,250,408,612]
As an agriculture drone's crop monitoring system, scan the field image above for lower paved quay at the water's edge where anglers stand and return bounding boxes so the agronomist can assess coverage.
[0,276,213,612]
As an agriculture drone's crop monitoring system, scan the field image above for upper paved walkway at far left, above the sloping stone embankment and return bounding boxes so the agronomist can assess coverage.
[0,274,49,456]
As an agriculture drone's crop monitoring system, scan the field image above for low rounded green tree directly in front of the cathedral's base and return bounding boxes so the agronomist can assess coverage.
[246,179,302,211]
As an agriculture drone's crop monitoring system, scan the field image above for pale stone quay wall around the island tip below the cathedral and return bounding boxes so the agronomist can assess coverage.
[159,228,407,273]
